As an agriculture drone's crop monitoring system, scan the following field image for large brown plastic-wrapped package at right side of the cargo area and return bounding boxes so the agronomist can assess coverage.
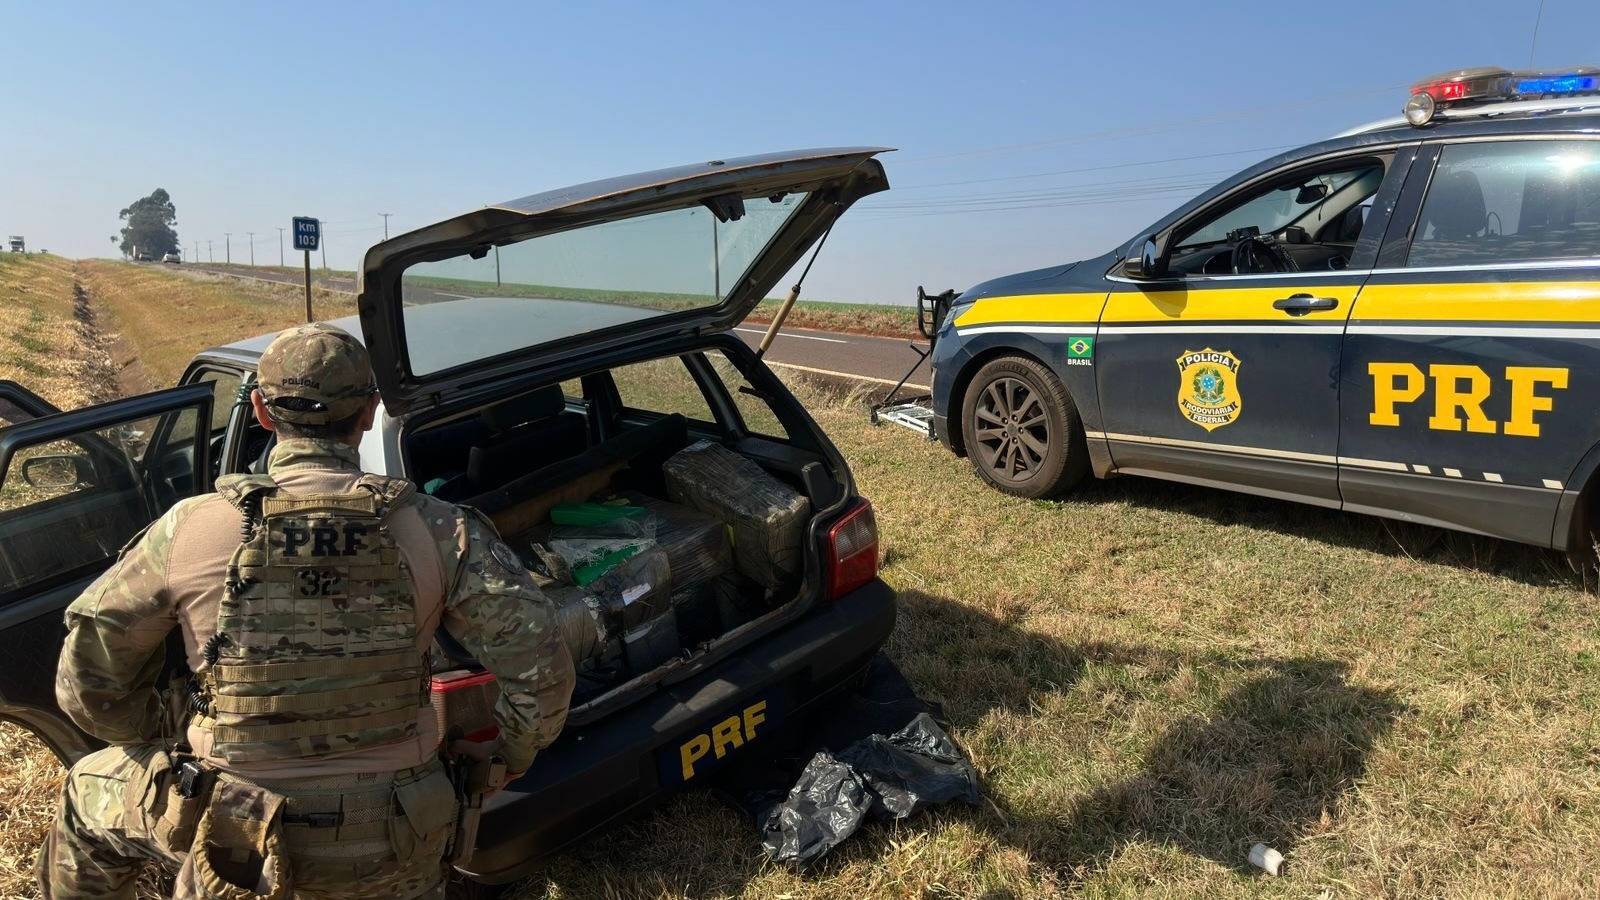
[662,440,811,588]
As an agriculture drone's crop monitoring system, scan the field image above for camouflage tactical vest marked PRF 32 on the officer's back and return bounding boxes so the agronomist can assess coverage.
[195,476,429,762]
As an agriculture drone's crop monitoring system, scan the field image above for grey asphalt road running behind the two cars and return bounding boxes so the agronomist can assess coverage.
[186,264,930,392]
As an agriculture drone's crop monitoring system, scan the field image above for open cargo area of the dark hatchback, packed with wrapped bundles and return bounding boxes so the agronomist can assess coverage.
[405,351,840,735]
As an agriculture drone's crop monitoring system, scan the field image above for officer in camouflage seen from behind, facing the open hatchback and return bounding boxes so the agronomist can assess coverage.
[38,325,573,900]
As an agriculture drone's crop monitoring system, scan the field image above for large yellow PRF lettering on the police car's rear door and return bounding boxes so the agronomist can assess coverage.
[1366,362,1568,437]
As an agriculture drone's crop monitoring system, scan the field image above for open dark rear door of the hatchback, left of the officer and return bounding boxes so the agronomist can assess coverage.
[0,381,211,762]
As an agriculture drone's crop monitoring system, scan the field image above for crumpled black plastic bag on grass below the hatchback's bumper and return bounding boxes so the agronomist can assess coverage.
[760,713,978,868]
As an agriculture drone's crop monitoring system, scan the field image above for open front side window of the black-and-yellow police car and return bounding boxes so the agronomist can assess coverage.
[1170,157,1386,275]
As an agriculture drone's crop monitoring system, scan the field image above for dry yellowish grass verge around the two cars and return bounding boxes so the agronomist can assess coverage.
[0,258,1600,900]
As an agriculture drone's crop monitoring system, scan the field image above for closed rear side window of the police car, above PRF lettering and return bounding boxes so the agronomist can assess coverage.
[1406,141,1600,267]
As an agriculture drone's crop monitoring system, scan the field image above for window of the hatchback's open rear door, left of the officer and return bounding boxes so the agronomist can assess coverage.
[0,398,200,604]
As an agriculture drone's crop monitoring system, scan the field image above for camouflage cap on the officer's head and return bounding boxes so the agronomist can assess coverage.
[256,322,378,424]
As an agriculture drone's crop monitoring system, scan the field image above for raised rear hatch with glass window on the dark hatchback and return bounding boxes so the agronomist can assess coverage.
[357,147,888,415]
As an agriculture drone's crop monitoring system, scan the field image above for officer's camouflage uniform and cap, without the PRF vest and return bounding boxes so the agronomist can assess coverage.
[38,327,573,900]
